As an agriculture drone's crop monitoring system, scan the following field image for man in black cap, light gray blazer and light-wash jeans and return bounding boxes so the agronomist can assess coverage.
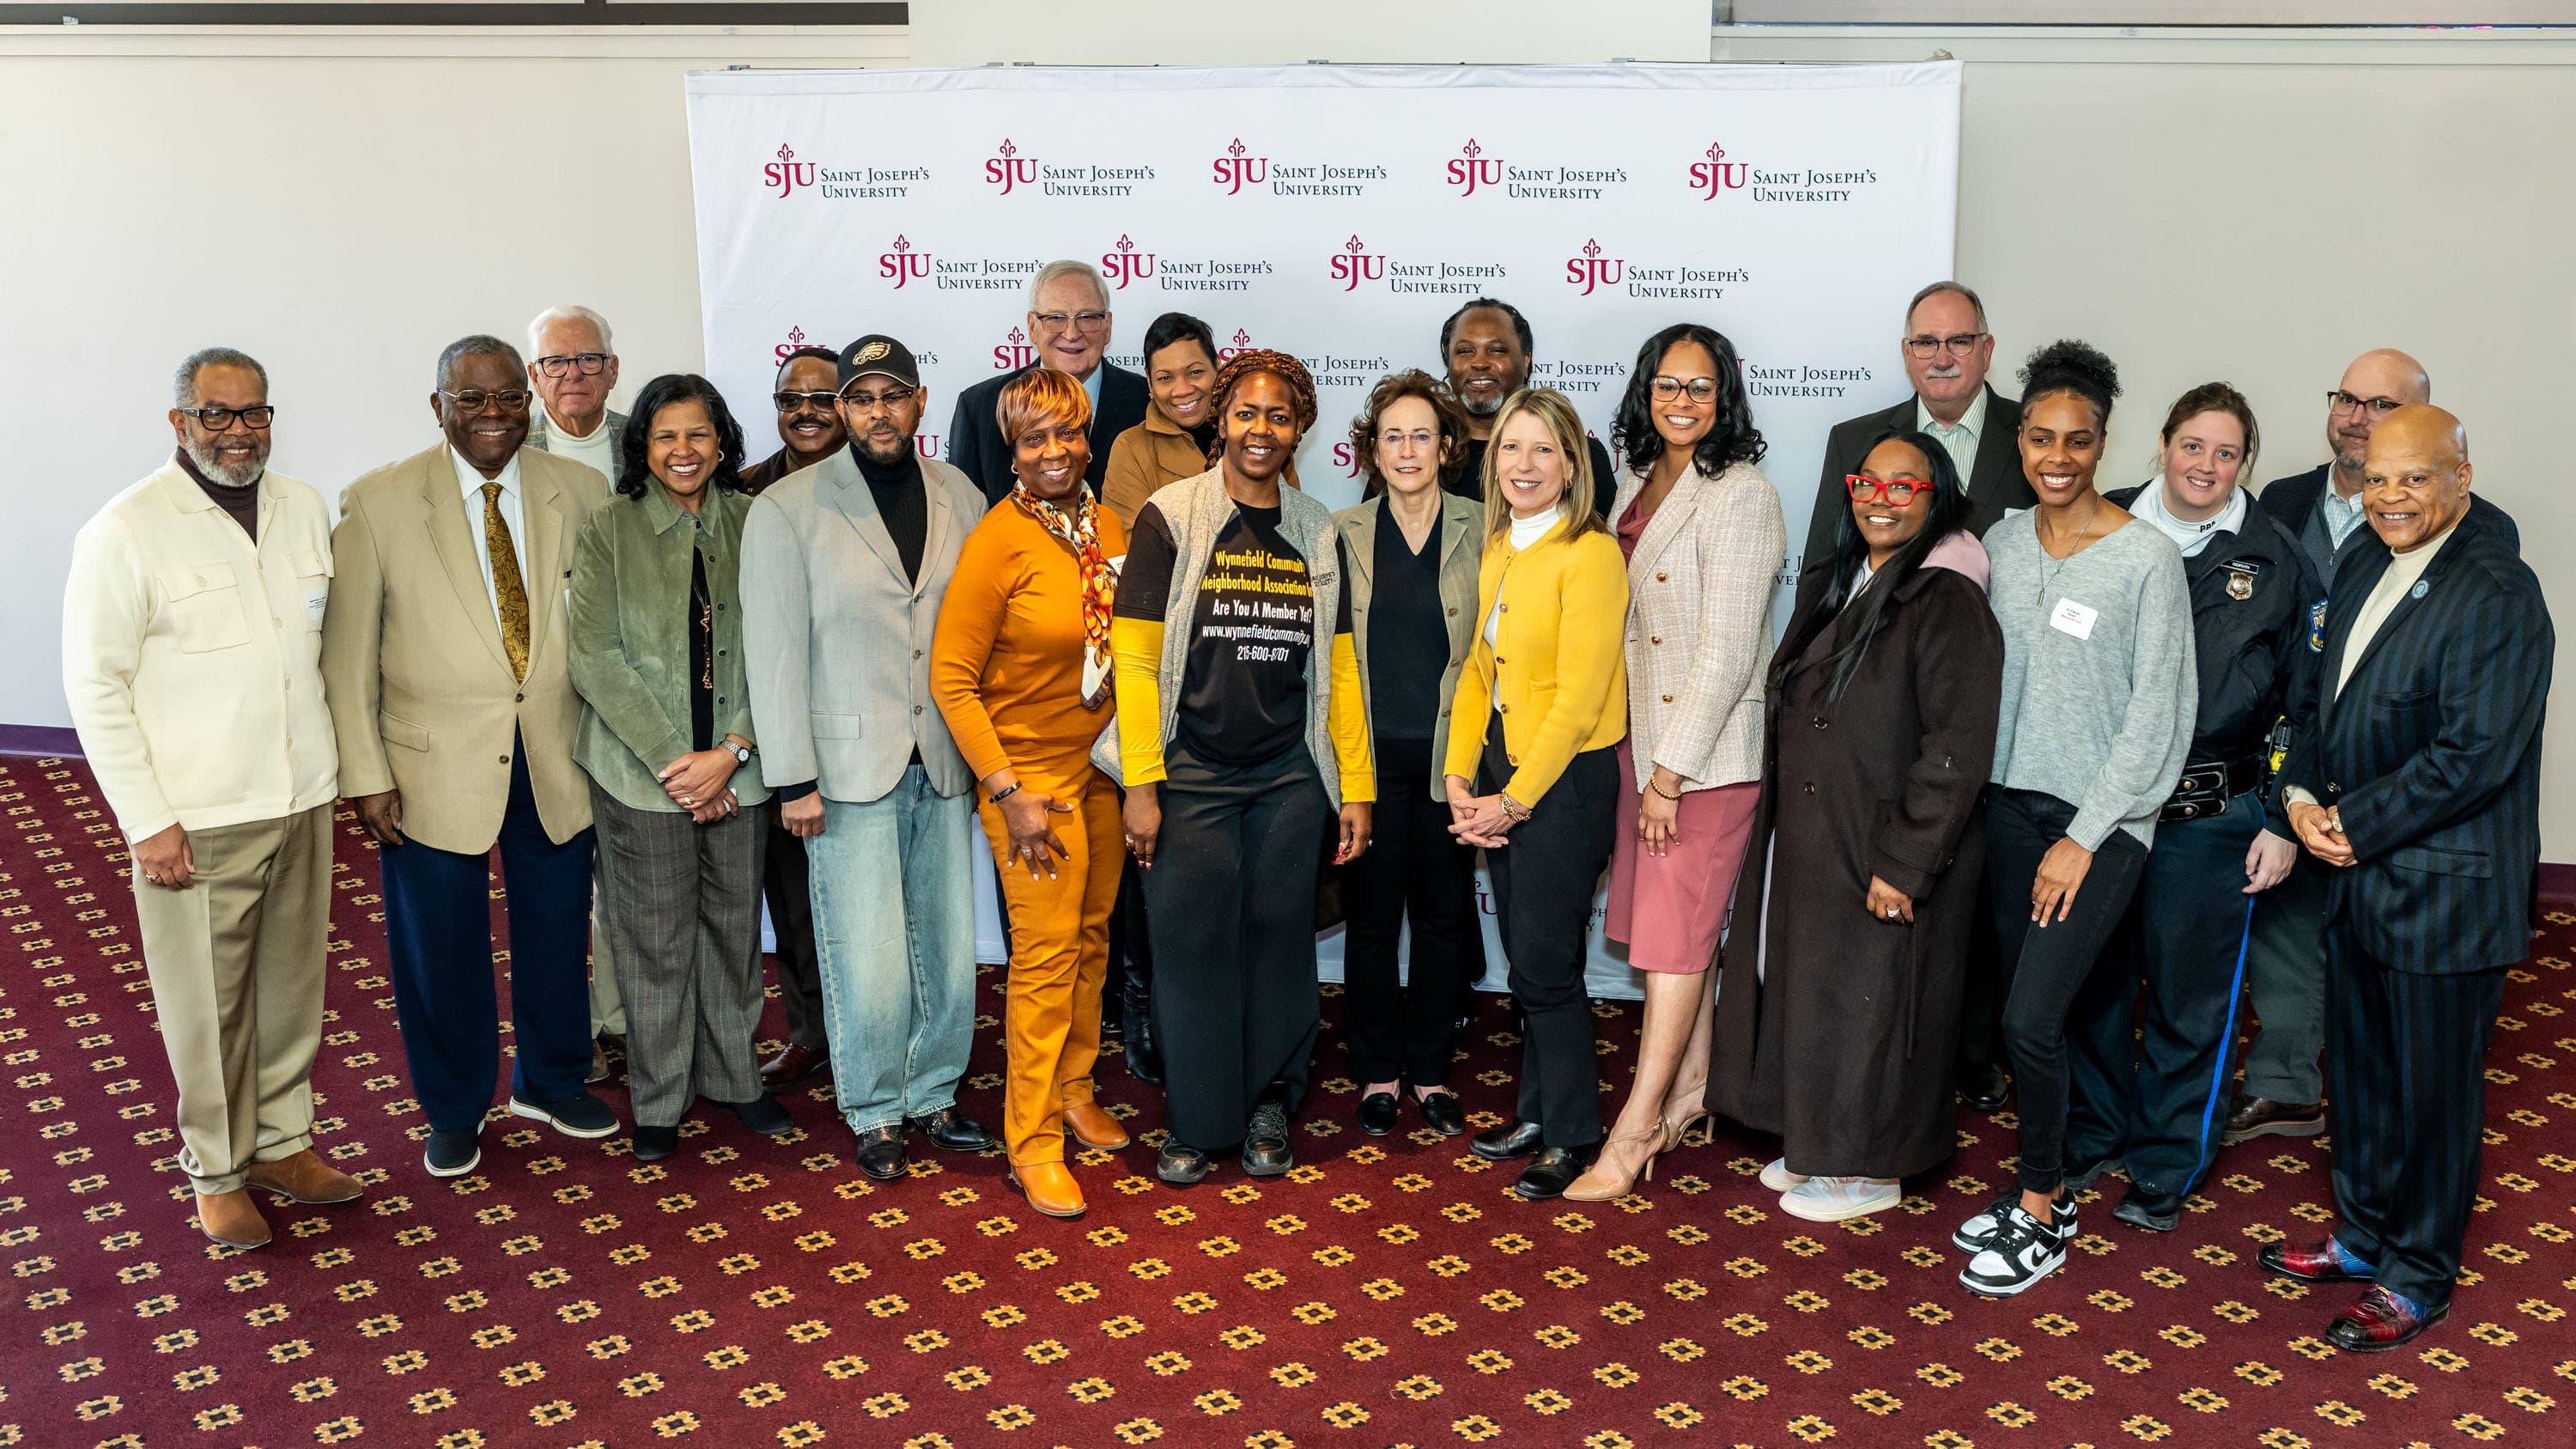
[742,335,992,1181]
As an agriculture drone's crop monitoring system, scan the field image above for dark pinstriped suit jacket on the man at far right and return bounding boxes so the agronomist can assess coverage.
[2280,510,2555,975]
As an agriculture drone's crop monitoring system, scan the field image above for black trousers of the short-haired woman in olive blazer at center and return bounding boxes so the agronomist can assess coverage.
[1342,738,1476,1088]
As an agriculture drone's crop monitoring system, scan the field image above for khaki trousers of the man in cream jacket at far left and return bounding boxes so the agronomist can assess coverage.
[131,805,332,1196]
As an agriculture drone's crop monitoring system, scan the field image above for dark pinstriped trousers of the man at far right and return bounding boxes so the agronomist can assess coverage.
[2326,923,2504,1307]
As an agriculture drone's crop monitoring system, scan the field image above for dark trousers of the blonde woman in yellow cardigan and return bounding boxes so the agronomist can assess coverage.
[1476,725,1625,1148]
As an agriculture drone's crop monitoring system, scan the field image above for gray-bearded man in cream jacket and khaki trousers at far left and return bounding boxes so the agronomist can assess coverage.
[62,348,358,1248]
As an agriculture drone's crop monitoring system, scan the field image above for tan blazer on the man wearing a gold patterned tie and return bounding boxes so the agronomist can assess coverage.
[322,438,608,856]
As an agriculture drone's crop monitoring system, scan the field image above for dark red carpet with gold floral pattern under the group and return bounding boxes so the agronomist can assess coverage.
[0,758,2576,1449]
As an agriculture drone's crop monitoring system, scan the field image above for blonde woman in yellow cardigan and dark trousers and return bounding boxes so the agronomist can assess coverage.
[1448,389,1628,1202]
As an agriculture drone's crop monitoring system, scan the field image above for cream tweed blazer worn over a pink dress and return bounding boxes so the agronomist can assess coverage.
[1610,464,1788,792]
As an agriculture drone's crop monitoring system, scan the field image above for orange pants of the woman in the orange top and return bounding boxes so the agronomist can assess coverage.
[979,761,1126,1168]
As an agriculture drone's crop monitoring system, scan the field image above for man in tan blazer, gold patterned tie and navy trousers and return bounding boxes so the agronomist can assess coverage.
[322,335,618,1178]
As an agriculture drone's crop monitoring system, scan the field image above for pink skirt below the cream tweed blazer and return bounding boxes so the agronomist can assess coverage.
[1607,740,1762,975]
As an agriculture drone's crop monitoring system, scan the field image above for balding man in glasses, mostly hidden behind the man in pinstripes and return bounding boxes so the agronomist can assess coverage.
[2226,348,2522,1142]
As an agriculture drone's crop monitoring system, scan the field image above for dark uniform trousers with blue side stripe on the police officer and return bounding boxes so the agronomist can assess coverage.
[2066,792,2262,1194]
